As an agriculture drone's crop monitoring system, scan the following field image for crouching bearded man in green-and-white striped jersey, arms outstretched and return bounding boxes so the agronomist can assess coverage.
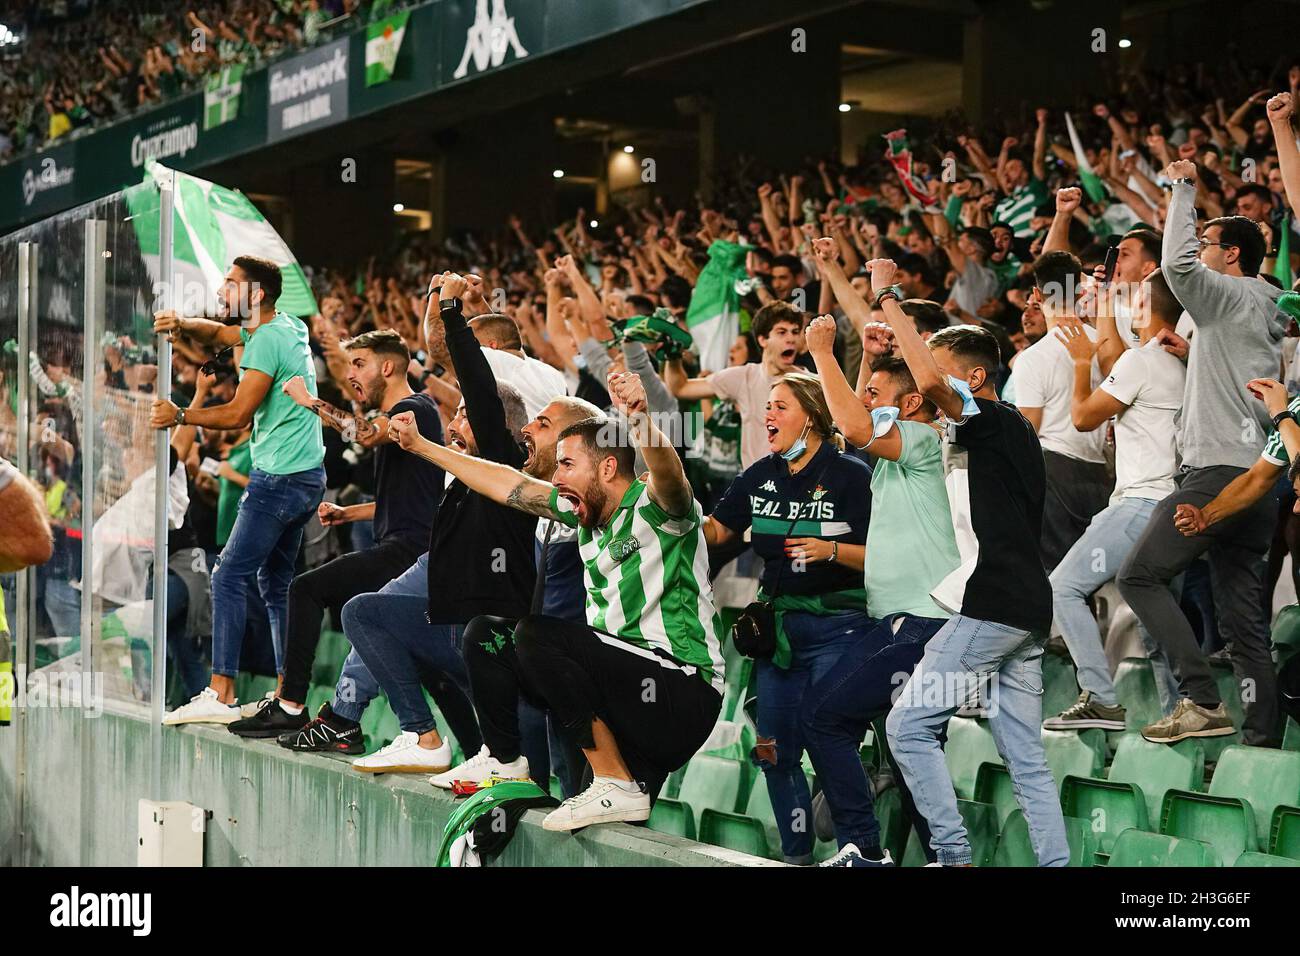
[393,372,723,830]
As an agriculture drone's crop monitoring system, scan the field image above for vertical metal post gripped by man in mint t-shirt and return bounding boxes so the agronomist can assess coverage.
[150,173,176,800]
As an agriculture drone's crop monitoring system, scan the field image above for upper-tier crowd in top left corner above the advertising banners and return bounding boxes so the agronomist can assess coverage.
[0,0,406,160]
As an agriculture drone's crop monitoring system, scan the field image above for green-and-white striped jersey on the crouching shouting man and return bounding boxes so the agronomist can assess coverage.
[551,479,723,692]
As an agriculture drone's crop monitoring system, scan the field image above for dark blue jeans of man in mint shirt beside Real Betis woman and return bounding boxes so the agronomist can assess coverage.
[802,614,944,849]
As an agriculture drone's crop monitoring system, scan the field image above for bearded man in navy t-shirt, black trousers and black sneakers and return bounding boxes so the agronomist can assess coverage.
[230,329,443,737]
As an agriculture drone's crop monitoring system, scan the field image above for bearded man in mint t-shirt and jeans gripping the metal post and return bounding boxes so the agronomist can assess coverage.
[150,256,325,724]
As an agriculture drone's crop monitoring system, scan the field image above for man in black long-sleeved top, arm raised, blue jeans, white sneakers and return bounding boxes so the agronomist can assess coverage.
[335,273,537,774]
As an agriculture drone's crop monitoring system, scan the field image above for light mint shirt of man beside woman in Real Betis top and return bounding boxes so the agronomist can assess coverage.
[866,421,961,619]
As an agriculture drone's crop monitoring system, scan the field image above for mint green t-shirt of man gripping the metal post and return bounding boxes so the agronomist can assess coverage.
[239,312,325,475]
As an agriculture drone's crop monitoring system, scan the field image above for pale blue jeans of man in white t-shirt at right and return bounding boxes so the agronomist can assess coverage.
[1052,498,1178,714]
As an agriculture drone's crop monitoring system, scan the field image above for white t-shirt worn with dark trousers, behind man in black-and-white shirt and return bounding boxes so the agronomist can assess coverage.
[1011,325,1106,463]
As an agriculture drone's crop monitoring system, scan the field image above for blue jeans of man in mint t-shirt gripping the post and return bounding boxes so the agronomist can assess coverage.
[212,468,325,678]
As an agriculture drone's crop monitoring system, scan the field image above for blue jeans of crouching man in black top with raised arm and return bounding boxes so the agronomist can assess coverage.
[339,553,469,734]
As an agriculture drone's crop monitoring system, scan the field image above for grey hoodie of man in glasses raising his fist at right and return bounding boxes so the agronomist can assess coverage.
[1160,183,1287,468]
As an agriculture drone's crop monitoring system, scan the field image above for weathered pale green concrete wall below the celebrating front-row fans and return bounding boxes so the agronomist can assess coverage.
[0,709,775,866]
